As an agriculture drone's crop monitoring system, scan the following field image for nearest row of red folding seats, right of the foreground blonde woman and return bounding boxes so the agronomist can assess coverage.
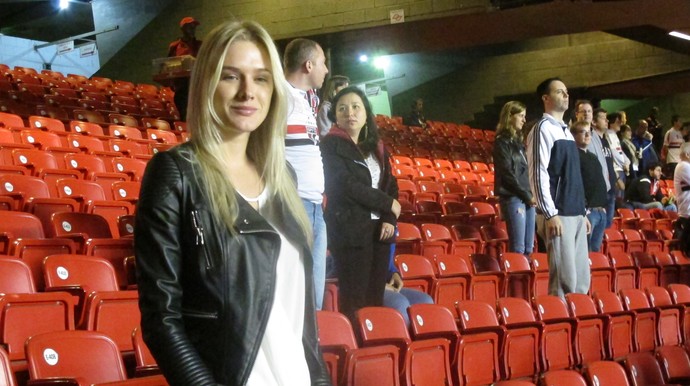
[317,285,690,385]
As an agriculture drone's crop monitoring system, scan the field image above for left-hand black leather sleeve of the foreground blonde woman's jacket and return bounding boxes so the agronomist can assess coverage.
[134,152,216,385]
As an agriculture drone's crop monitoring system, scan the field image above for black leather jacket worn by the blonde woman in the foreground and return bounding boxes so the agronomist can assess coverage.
[134,143,330,386]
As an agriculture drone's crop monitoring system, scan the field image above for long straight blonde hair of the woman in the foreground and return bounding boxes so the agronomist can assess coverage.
[187,21,312,243]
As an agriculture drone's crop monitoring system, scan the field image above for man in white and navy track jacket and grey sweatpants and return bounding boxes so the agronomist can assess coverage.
[527,78,590,297]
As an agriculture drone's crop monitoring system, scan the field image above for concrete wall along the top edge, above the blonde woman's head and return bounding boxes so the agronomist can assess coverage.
[98,0,490,83]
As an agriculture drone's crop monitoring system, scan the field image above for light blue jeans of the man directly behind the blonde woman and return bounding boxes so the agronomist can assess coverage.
[302,199,328,310]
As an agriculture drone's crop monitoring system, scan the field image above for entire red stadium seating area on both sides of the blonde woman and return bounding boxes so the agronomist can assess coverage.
[0,65,690,386]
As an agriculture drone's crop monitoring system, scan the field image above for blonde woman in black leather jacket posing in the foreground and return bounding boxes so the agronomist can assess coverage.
[134,22,329,385]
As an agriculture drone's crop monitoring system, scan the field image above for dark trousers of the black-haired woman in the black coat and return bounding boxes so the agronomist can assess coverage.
[330,220,390,325]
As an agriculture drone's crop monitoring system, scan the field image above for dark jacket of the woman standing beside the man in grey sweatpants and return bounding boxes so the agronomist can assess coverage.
[494,135,532,204]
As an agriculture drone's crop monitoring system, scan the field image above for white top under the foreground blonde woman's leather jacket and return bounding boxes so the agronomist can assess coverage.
[245,188,311,386]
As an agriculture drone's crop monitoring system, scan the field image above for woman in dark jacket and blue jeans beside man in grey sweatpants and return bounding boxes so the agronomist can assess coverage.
[494,101,536,256]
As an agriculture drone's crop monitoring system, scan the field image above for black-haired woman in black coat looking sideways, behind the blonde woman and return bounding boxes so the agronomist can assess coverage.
[321,87,400,321]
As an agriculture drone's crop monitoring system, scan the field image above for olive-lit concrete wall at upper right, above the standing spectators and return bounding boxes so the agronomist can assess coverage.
[392,32,690,128]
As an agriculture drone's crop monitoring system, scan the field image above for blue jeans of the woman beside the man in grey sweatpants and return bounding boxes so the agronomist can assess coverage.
[499,196,535,255]
